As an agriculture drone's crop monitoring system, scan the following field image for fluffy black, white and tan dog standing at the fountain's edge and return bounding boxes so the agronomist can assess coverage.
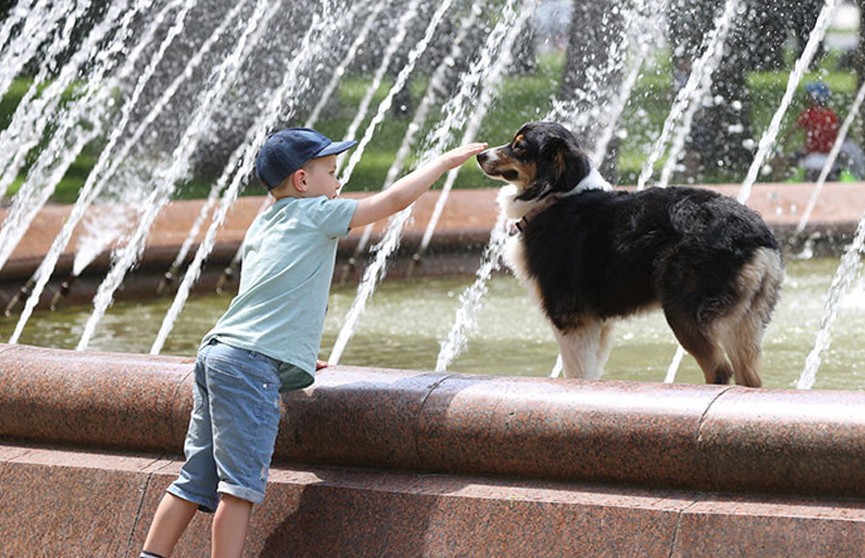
[477,122,784,387]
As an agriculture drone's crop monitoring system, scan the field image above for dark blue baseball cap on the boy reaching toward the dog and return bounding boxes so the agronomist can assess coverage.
[255,128,357,190]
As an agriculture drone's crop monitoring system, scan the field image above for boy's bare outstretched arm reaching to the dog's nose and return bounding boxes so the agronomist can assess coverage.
[349,143,487,228]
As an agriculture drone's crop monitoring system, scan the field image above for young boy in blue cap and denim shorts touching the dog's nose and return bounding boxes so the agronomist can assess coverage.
[141,128,486,557]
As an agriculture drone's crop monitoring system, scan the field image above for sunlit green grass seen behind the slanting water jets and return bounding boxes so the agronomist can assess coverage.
[0,46,859,203]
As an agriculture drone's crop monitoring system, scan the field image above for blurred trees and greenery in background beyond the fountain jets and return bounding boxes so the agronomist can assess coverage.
[0,0,865,203]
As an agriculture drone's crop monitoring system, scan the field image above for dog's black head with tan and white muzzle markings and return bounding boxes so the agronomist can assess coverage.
[477,122,592,203]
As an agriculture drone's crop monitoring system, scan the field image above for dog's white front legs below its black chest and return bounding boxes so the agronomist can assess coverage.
[553,319,610,380]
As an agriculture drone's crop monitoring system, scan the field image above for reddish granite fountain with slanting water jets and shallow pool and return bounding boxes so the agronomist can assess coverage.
[0,0,865,556]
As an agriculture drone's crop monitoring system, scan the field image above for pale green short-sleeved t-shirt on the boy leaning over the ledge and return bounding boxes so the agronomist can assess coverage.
[201,196,357,391]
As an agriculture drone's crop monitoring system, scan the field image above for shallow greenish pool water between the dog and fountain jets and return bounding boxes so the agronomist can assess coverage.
[0,259,865,390]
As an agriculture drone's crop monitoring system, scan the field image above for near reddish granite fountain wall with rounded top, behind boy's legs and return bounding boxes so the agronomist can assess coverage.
[0,345,865,557]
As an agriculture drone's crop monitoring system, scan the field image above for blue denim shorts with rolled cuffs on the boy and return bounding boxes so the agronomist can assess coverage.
[168,340,280,512]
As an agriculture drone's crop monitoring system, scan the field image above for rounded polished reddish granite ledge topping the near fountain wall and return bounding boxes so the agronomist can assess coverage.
[0,345,865,498]
